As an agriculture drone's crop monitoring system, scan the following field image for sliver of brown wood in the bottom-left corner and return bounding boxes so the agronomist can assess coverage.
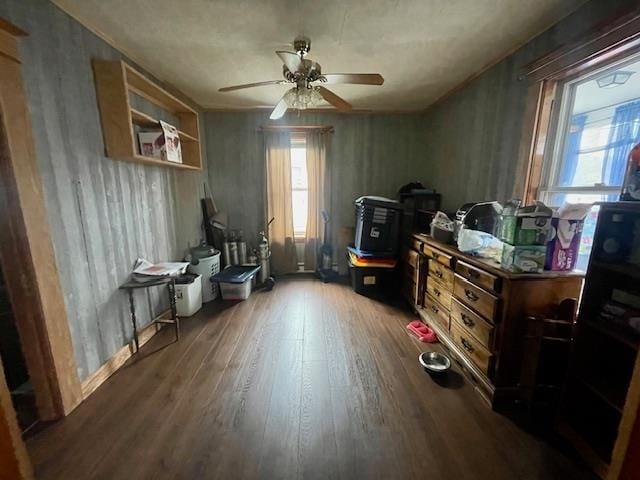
[0,356,33,480]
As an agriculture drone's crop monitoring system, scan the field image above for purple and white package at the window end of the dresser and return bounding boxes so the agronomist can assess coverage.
[544,204,591,271]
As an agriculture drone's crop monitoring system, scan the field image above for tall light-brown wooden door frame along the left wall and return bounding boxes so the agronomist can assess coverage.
[0,18,82,420]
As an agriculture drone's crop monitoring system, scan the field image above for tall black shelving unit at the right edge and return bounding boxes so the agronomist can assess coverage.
[558,202,640,478]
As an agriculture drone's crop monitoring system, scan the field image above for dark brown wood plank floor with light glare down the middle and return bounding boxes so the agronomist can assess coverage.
[28,278,589,480]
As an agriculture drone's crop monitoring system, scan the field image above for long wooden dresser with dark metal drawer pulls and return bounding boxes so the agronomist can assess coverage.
[404,234,583,406]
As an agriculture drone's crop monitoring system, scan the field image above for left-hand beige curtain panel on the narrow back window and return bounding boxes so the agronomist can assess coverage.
[264,131,298,275]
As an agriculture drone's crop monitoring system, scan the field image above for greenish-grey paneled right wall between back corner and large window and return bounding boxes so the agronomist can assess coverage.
[421,0,637,211]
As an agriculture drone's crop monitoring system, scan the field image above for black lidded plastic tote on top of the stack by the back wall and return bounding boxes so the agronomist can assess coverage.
[355,197,402,254]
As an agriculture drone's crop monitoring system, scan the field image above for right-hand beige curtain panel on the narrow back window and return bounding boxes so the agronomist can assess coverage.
[304,130,331,270]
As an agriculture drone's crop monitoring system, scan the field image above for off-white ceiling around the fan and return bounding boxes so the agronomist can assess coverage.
[53,0,585,110]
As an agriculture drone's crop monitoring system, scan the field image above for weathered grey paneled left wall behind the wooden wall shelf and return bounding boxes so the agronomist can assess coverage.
[0,0,206,380]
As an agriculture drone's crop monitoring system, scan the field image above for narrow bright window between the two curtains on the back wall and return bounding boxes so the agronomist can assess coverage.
[291,135,309,238]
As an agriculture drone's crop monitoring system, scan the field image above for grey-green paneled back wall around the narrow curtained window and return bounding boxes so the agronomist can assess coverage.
[202,112,428,272]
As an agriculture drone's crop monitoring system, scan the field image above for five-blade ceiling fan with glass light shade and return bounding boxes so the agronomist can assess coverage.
[218,37,384,120]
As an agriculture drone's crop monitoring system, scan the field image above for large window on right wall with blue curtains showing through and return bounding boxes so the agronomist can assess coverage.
[539,55,640,206]
